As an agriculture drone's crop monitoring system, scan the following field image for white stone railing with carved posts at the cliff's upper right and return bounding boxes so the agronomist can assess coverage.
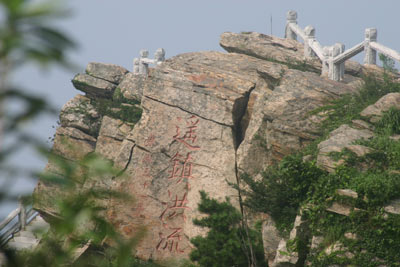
[285,10,400,81]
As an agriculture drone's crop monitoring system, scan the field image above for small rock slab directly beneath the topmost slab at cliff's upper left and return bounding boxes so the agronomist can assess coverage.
[72,74,117,98]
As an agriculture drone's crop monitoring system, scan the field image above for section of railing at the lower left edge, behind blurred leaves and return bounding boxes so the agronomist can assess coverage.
[0,201,39,247]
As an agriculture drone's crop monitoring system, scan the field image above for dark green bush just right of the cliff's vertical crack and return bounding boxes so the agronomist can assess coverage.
[242,155,325,234]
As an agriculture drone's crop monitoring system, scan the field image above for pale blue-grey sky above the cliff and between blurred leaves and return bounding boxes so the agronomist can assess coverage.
[0,0,400,220]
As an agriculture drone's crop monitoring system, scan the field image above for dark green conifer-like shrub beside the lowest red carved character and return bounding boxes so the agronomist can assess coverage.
[190,191,265,267]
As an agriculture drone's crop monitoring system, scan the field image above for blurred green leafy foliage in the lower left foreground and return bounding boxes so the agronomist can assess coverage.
[5,154,159,267]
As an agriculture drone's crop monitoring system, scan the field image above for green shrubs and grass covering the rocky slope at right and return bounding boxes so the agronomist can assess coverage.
[244,76,400,266]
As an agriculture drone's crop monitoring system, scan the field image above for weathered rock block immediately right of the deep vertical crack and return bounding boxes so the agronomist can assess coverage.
[238,69,354,175]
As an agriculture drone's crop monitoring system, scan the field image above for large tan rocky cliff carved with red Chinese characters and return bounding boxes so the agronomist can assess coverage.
[34,33,400,263]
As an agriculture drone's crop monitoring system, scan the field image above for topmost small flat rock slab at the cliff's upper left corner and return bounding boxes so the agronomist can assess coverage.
[86,62,129,84]
